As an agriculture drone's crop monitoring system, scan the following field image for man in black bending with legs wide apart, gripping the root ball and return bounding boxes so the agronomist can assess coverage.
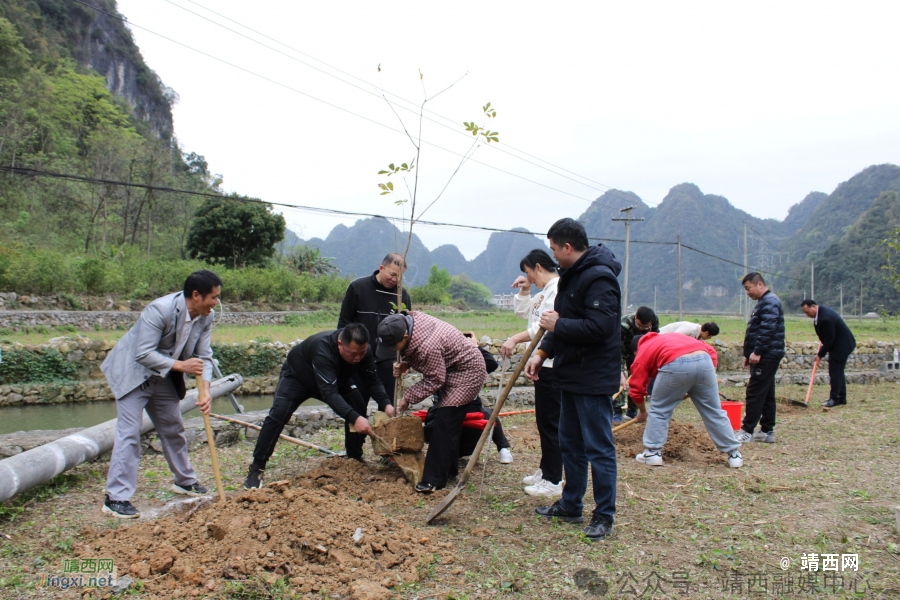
[244,323,394,489]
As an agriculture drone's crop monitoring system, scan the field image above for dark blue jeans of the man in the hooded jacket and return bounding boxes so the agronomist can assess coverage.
[559,391,618,524]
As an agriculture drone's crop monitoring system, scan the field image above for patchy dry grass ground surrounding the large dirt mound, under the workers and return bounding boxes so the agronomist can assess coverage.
[0,384,900,600]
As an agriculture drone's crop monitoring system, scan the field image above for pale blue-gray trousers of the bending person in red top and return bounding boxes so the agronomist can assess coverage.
[644,352,741,452]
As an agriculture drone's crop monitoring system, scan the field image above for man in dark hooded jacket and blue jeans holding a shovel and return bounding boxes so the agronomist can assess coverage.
[525,219,622,539]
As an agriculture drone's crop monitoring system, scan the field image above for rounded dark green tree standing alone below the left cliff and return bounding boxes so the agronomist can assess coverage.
[187,195,285,268]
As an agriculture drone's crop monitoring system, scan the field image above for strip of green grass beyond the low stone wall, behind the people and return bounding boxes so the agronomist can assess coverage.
[0,309,900,344]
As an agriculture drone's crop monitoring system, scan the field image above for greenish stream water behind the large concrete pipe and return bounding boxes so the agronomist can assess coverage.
[0,395,322,434]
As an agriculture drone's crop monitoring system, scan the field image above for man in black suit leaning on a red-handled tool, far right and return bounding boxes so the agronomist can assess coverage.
[800,300,856,408]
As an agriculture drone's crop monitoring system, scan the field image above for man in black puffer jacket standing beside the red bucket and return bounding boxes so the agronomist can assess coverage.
[734,273,784,444]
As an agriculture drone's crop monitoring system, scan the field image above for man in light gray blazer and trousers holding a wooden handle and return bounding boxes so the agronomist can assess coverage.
[100,271,222,519]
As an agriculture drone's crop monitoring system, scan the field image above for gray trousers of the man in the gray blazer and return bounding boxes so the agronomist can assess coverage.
[106,377,197,501]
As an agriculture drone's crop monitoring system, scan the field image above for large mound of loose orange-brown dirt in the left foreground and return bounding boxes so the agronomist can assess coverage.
[77,459,449,598]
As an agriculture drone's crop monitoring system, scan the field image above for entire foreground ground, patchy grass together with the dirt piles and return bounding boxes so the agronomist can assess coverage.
[0,384,900,600]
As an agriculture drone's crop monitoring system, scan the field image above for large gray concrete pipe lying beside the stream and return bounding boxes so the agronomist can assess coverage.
[0,374,244,502]
